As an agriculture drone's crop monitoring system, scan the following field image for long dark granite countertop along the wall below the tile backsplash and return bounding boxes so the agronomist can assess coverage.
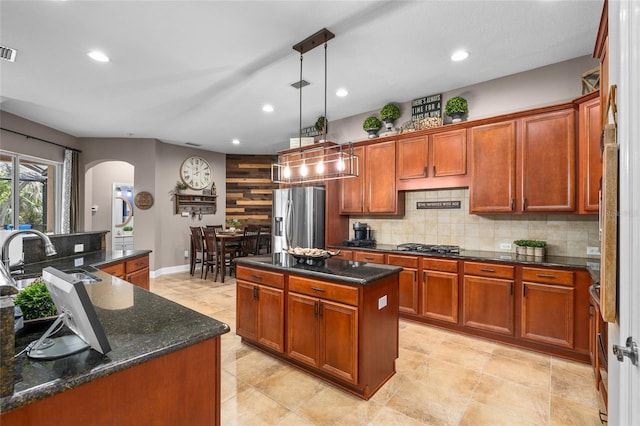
[329,244,600,271]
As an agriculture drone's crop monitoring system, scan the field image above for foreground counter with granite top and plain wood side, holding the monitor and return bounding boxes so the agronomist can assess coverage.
[0,268,229,425]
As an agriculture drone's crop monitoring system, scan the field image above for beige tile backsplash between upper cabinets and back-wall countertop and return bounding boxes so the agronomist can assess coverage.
[349,188,600,257]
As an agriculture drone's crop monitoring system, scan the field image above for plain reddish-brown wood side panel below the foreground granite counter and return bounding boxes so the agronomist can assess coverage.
[0,337,221,426]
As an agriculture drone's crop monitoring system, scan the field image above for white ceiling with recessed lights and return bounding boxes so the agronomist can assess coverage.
[0,0,602,154]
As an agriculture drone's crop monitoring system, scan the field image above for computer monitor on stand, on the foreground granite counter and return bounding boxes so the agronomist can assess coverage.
[27,267,111,359]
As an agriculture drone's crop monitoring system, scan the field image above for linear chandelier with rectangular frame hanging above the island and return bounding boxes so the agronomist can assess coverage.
[271,28,358,183]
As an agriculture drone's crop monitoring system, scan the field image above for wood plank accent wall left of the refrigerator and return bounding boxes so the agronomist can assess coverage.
[225,154,278,228]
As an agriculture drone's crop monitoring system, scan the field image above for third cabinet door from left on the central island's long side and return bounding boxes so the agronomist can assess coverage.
[287,292,320,367]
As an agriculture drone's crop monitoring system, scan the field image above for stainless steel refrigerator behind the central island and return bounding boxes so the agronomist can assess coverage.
[271,186,325,253]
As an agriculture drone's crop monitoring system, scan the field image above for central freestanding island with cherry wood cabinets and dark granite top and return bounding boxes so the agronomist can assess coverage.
[236,253,402,399]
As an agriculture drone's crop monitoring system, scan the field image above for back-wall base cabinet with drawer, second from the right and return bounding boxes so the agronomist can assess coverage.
[462,262,515,336]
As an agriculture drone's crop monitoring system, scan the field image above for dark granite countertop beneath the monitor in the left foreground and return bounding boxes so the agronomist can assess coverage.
[1,270,229,414]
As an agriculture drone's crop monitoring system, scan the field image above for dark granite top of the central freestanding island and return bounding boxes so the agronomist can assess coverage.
[235,253,402,285]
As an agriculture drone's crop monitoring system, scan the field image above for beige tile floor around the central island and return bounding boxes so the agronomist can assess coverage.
[151,272,600,426]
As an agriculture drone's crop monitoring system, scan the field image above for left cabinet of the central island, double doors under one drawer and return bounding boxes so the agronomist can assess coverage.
[236,265,285,353]
